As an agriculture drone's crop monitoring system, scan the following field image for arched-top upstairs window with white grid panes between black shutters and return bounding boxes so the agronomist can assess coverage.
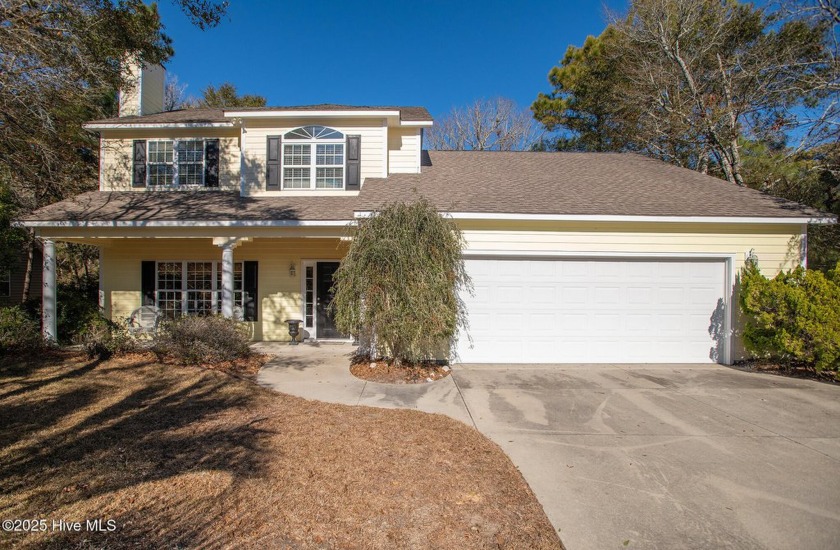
[283,126,344,189]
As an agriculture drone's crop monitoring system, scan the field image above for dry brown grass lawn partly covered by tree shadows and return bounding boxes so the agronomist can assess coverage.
[0,355,561,549]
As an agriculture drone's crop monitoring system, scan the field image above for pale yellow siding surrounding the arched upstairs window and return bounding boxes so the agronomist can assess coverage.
[242,118,393,195]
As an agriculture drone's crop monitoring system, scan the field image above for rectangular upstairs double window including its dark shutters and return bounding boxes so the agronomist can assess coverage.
[133,139,219,187]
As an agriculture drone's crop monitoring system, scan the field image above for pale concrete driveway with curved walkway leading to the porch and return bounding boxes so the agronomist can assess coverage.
[259,346,840,550]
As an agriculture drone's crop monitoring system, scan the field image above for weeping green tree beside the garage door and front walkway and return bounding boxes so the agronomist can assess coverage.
[331,198,470,364]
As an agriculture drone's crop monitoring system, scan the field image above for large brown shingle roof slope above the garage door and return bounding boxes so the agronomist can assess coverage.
[357,151,821,218]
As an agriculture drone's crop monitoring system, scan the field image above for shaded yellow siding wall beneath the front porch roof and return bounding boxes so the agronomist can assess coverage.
[101,238,347,340]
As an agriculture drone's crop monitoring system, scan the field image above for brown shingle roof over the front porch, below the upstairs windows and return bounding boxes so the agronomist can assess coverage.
[22,191,356,222]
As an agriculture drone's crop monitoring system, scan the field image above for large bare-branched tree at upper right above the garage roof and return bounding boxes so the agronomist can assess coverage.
[613,0,830,185]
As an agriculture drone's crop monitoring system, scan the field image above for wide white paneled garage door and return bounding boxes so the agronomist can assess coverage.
[458,259,725,363]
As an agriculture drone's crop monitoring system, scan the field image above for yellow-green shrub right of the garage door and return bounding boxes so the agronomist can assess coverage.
[740,261,840,372]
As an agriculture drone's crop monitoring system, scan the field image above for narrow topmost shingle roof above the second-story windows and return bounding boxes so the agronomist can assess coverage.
[88,103,432,124]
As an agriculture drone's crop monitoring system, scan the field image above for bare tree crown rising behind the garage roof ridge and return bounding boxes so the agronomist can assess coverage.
[424,97,542,151]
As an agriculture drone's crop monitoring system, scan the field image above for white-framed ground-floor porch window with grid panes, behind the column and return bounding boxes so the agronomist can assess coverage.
[155,261,243,319]
